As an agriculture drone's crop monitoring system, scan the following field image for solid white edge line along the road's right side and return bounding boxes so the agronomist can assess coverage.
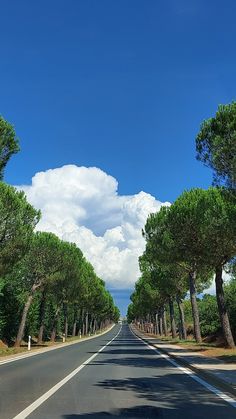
[130,328,236,408]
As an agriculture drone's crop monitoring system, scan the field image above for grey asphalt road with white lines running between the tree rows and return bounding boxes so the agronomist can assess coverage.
[0,325,236,419]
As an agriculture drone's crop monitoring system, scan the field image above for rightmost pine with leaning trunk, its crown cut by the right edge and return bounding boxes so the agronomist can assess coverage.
[201,188,236,348]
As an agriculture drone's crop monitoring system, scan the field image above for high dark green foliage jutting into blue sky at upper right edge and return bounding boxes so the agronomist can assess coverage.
[196,102,236,190]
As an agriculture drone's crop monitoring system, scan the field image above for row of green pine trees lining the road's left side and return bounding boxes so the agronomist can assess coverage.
[0,117,120,347]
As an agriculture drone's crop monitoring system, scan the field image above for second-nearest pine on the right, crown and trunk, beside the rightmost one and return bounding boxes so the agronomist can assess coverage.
[144,195,213,342]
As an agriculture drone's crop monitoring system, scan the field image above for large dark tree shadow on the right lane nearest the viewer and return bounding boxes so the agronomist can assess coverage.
[94,372,232,419]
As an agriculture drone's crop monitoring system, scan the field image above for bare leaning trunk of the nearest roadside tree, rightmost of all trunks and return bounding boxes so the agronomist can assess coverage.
[215,266,235,348]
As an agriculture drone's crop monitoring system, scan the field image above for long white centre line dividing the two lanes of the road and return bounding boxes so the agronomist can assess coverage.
[13,326,122,419]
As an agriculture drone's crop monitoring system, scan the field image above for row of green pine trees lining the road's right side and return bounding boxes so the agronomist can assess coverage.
[128,102,236,348]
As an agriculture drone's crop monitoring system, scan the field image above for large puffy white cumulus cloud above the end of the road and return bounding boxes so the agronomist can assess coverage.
[18,165,170,289]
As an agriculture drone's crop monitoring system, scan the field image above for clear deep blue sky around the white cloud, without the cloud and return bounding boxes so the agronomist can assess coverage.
[0,0,236,316]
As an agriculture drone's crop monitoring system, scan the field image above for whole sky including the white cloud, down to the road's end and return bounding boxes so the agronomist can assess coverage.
[0,0,236,314]
